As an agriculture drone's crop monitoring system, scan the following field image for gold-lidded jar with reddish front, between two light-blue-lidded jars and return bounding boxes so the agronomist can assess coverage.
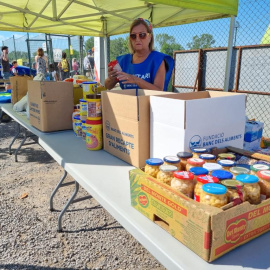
[220,179,247,204]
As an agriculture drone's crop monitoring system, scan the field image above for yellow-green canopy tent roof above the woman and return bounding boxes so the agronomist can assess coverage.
[0,0,238,37]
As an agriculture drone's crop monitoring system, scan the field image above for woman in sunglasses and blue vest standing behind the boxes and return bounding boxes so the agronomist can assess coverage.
[105,18,174,91]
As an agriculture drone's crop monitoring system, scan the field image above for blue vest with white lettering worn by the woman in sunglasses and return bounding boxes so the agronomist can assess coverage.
[116,51,174,91]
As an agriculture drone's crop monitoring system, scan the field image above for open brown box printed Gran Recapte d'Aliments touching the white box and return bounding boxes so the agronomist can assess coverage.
[101,89,175,167]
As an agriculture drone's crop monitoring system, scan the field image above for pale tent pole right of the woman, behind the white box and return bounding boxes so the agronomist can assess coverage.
[224,16,235,92]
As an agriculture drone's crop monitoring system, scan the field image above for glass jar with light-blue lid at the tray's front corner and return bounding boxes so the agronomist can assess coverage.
[200,183,227,208]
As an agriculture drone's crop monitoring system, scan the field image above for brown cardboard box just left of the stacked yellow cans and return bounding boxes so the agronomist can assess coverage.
[28,81,73,132]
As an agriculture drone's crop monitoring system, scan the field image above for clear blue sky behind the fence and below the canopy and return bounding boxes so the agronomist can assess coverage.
[0,0,270,49]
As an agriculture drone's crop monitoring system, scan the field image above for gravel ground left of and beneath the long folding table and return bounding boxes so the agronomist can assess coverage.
[0,121,165,270]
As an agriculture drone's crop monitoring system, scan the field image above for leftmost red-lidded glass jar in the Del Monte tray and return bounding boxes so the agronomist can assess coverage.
[171,171,194,198]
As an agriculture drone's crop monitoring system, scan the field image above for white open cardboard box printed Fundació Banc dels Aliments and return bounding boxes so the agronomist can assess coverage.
[150,91,246,158]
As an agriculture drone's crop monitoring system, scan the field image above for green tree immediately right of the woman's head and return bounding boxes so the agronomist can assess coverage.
[156,34,184,56]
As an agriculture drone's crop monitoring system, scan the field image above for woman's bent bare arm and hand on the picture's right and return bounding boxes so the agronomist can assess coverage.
[117,61,166,91]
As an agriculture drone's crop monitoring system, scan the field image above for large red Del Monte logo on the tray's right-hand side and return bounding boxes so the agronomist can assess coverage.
[225,219,247,243]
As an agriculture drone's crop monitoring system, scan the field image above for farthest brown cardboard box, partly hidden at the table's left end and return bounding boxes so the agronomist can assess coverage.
[9,76,33,104]
